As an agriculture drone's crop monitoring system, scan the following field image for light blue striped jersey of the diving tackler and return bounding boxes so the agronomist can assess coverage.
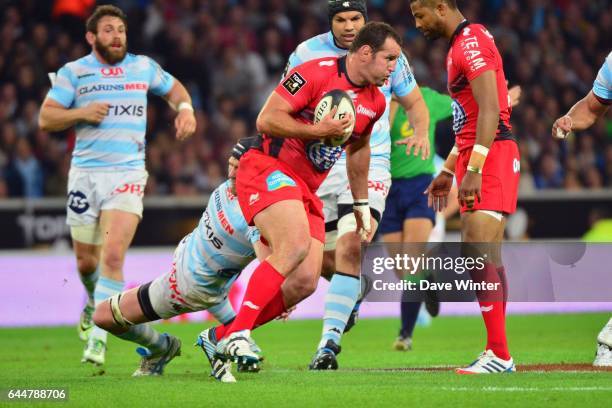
[181,181,259,295]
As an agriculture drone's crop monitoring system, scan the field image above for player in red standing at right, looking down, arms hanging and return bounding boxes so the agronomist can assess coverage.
[410,0,520,374]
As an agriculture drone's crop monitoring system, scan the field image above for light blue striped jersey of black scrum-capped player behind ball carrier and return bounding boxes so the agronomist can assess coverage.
[285,31,416,164]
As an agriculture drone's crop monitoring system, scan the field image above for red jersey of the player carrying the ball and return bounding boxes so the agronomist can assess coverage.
[263,57,386,192]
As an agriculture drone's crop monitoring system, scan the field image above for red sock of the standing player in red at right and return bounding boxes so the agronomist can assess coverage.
[472,263,510,360]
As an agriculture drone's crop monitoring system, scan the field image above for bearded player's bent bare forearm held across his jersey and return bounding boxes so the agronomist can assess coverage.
[38,98,110,132]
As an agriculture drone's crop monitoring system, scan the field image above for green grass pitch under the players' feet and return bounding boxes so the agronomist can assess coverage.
[0,314,612,408]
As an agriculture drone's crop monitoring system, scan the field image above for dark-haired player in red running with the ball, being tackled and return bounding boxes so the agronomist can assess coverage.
[211,22,401,363]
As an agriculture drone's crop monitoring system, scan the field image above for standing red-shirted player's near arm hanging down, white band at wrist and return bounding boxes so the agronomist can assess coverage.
[459,70,500,208]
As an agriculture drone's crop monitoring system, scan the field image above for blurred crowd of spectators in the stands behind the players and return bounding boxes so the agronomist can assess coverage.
[0,0,612,197]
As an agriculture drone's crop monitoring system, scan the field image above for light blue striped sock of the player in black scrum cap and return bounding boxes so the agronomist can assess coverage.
[319,272,361,348]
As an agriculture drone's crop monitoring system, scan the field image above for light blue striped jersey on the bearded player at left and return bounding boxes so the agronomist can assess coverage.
[47,52,174,171]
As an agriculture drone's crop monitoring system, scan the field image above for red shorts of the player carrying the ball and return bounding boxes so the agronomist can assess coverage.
[236,150,325,243]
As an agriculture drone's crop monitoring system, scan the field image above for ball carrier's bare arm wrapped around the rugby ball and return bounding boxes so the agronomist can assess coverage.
[257,92,353,140]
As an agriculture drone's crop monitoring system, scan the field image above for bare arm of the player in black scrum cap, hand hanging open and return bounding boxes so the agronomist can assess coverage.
[397,86,431,160]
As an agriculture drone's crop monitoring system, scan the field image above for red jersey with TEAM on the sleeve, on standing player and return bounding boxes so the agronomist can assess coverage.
[446,21,513,150]
